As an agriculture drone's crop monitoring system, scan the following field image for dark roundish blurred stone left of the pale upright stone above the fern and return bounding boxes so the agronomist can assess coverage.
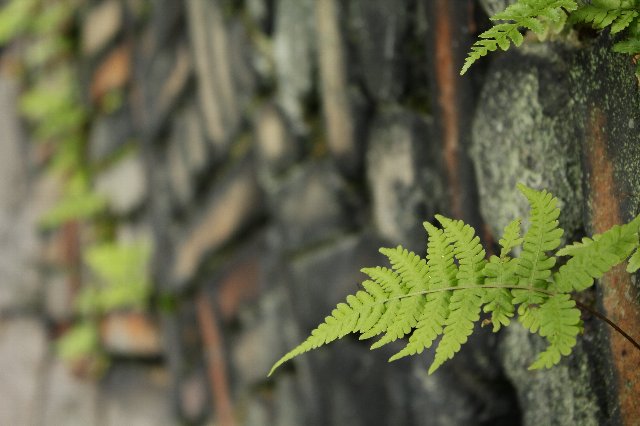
[270,161,358,249]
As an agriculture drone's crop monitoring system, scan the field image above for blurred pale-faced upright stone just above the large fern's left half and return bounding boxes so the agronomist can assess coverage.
[367,110,446,255]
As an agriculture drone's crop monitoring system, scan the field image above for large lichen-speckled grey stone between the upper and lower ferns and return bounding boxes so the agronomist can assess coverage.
[471,45,583,241]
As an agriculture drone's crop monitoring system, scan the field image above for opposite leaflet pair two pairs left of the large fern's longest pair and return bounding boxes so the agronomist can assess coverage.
[371,246,429,349]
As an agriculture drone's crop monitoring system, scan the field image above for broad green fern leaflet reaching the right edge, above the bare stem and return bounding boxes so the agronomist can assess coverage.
[554,216,640,293]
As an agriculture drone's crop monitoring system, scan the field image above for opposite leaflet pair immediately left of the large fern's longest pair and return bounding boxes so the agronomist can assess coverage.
[389,222,457,361]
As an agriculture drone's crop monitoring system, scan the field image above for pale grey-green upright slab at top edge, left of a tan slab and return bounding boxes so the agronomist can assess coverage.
[273,0,316,132]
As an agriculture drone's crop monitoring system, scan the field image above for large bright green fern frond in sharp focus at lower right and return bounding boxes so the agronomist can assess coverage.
[269,185,640,374]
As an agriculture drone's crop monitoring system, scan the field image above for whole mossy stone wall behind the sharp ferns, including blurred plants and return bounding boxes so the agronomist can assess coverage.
[0,0,640,426]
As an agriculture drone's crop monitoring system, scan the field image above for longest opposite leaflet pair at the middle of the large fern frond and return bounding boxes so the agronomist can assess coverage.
[429,215,486,374]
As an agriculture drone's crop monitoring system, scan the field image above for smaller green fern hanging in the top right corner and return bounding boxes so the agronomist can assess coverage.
[460,0,640,76]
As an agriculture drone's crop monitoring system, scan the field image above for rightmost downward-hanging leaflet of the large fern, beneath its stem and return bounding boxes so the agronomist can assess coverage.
[529,294,582,370]
